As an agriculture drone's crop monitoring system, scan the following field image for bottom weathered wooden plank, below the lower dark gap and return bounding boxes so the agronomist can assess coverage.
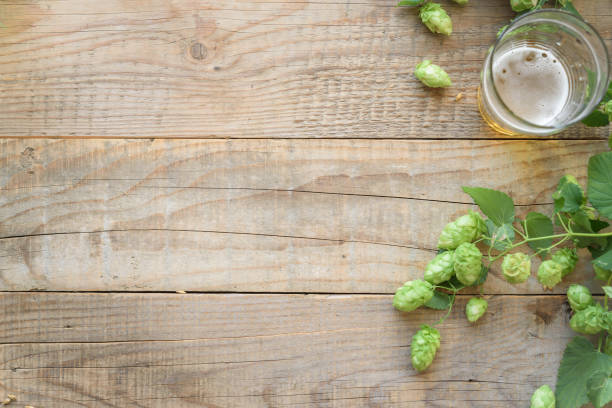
[0,293,573,408]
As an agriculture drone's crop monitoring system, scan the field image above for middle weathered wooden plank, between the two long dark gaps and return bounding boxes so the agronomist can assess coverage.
[0,140,606,293]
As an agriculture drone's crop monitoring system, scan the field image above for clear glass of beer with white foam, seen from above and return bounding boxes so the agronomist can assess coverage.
[478,9,609,136]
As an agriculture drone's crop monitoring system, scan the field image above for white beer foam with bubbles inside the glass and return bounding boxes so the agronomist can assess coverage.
[493,46,570,126]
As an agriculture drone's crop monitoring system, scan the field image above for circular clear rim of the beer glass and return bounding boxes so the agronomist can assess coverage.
[487,8,610,131]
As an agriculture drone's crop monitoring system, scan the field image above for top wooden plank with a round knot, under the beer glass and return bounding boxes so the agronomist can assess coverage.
[0,0,612,139]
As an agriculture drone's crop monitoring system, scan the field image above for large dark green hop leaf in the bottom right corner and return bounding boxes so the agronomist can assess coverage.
[555,336,612,408]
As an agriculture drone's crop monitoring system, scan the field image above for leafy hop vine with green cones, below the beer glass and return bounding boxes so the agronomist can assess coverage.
[393,152,612,396]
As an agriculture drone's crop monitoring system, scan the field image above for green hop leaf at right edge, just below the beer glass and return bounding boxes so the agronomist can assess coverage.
[588,152,612,218]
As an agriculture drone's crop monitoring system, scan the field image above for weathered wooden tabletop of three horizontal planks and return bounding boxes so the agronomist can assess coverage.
[0,0,612,408]
